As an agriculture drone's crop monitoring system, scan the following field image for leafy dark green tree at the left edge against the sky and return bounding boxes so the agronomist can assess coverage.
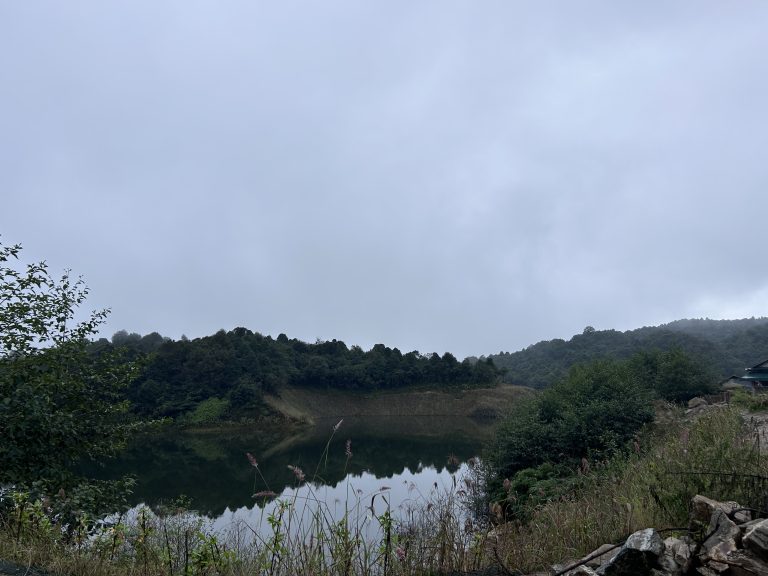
[0,245,134,492]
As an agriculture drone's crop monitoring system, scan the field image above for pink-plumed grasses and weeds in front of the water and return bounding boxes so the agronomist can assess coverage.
[0,422,483,576]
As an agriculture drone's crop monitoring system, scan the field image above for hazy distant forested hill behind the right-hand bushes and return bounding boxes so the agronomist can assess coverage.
[488,318,768,388]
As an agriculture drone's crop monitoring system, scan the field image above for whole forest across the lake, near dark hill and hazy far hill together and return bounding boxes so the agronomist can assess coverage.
[91,318,768,418]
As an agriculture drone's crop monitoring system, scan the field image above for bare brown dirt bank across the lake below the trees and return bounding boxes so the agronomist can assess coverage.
[265,384,533,421]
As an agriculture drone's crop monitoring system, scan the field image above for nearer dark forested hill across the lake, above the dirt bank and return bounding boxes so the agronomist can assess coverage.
[93,328,500,417]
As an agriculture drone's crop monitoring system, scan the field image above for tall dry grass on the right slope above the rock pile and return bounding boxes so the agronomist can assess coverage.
[492,407,768,572]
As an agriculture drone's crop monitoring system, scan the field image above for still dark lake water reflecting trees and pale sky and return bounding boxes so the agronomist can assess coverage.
[96,417,493,530]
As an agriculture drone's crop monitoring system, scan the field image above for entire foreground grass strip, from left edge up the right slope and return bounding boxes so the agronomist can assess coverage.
[0,407,768,576]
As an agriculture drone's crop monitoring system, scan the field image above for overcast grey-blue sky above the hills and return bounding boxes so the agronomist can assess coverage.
[0,0,768,357]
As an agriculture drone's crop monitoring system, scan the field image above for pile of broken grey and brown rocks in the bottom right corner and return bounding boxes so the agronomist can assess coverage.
[552,496,768,576]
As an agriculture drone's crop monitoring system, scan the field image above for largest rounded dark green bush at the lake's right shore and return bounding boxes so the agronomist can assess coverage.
[486,361,654,505]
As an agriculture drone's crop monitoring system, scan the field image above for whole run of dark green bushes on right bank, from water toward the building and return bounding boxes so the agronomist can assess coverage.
[485,348,715,520]
